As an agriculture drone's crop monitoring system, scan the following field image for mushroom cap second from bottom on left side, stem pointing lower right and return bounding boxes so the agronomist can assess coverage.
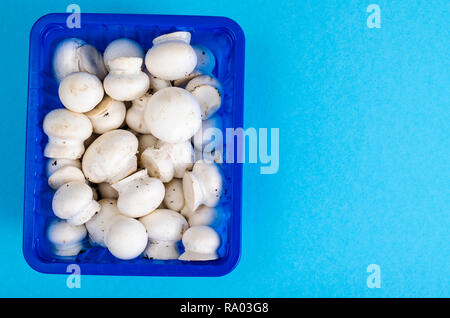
[52,181,97,219]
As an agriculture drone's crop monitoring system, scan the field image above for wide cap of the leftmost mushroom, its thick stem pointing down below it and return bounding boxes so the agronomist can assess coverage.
[43,108,92,141]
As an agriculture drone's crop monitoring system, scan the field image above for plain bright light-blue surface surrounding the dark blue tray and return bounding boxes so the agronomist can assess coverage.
[0,0,450,297]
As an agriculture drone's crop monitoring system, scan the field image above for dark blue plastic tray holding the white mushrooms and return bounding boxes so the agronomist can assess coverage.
[23,13,245,276]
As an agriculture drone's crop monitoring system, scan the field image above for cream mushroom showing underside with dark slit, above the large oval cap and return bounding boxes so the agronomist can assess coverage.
[85,95,127,134]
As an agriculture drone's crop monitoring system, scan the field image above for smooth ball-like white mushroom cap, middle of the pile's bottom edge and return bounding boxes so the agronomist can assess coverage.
[105,216,148,260]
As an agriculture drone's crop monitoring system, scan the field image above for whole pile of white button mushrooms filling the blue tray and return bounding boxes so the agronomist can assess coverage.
[43,31,222,261]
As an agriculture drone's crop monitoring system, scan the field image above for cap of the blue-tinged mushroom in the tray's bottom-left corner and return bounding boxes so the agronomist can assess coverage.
[47,219,87,248]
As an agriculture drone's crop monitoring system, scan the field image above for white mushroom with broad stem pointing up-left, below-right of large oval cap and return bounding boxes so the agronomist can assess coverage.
[112,169,165,218]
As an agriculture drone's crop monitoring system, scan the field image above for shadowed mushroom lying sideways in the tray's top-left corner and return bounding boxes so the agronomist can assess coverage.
[53,38,106,82]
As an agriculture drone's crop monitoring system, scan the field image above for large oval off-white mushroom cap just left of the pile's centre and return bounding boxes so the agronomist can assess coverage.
[82,129,138,183]
